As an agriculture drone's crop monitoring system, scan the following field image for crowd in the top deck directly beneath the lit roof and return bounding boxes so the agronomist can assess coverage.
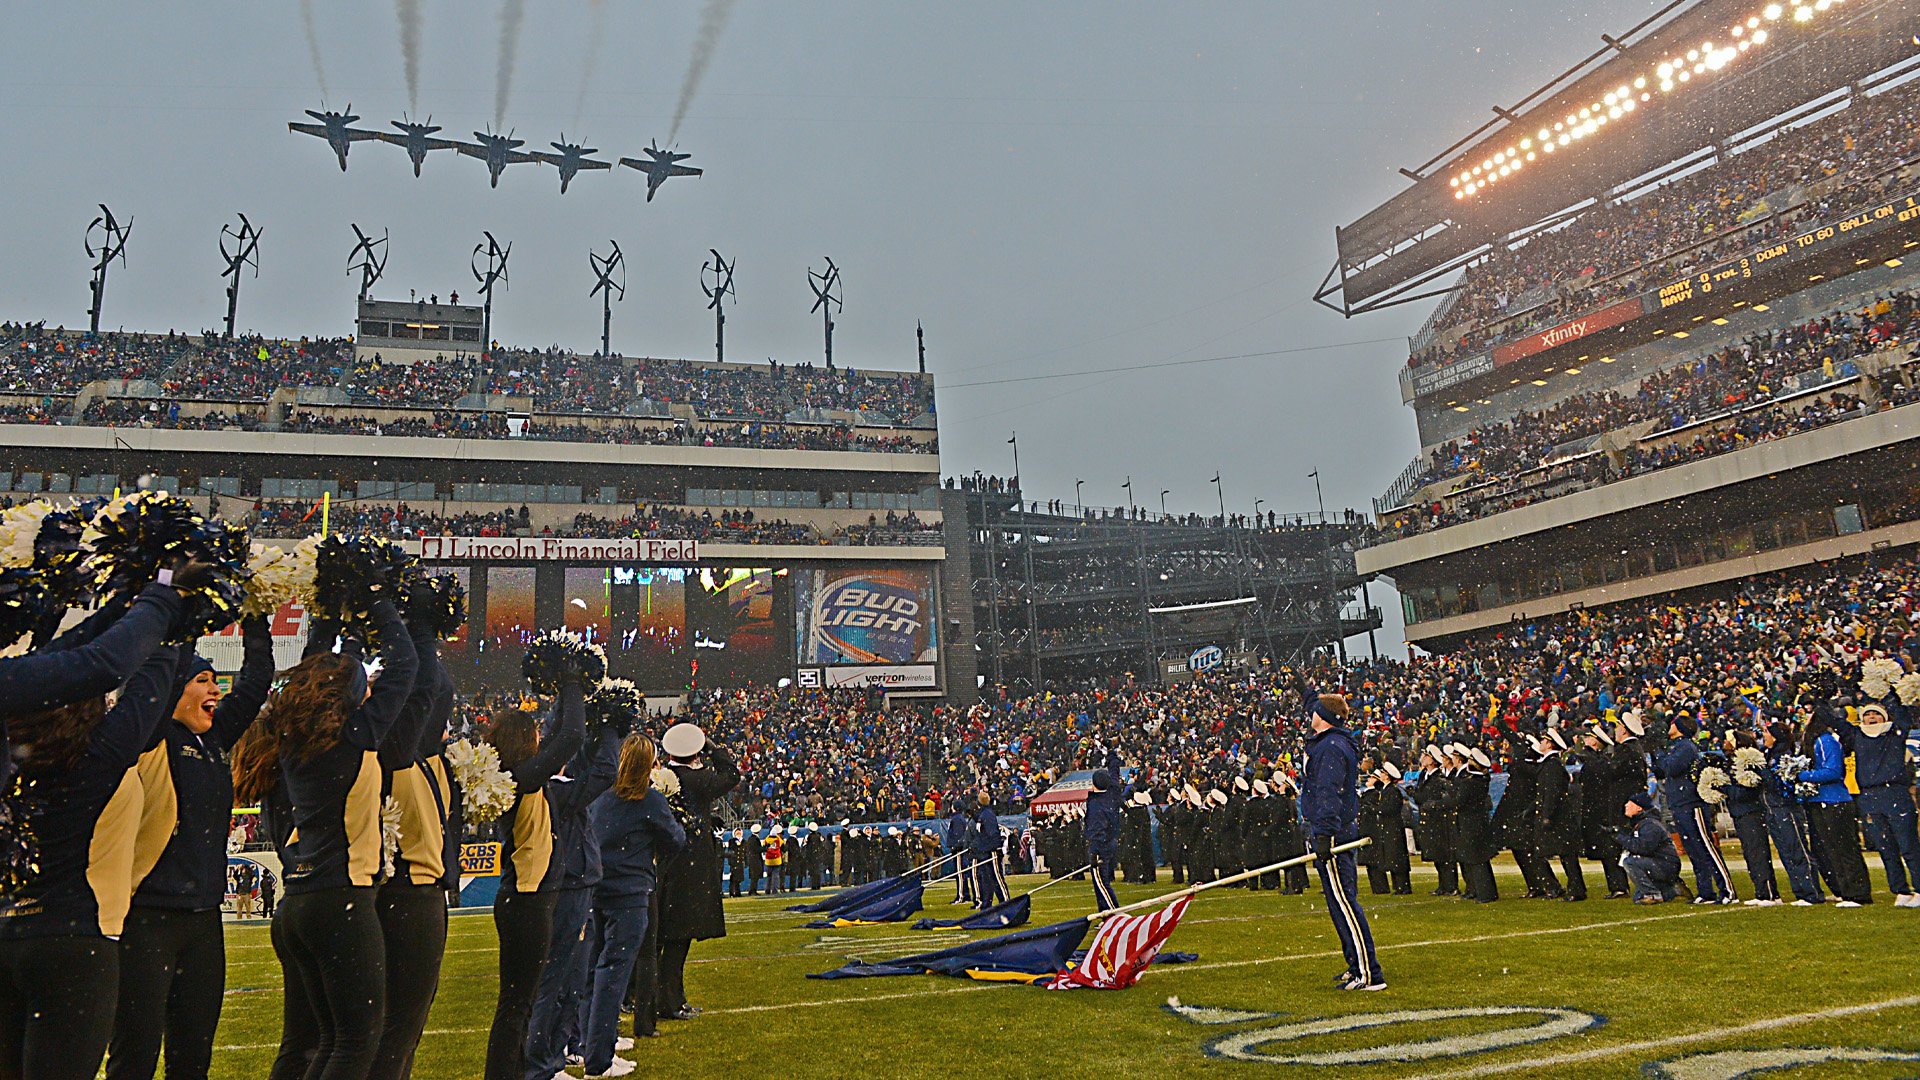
[1407,81,1920,367]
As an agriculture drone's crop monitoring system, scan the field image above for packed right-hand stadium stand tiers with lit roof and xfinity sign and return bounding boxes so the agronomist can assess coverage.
[1319,0,1920,648]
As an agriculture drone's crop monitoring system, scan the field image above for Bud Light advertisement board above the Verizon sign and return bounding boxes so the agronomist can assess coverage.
[793,569,939,665]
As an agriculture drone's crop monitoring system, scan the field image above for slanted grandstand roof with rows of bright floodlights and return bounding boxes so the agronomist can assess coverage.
[1315,0,1920,317]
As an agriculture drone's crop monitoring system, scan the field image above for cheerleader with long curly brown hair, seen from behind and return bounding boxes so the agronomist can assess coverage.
[234,600,419,1080]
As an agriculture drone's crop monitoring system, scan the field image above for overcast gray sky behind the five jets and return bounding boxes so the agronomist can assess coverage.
[0,0,1653,645]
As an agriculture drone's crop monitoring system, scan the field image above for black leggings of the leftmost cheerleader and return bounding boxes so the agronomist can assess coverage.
[0,936,119,1080]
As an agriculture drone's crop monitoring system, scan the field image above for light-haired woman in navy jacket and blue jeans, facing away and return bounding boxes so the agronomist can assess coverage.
[582,734,687,1076]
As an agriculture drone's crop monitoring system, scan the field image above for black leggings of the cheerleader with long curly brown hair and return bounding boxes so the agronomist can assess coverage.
[275,886,386,1080]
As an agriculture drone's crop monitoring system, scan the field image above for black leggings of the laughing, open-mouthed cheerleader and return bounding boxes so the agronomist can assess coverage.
[108,907,227,1080]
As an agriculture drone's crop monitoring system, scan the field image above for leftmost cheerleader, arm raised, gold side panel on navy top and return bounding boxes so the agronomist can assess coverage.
[0,576,191,1080]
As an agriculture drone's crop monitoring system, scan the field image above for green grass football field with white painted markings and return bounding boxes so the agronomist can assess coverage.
[215,865,1920,1080]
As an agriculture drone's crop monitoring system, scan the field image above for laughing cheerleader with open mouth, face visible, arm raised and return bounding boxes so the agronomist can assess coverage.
[108,617,273,1080]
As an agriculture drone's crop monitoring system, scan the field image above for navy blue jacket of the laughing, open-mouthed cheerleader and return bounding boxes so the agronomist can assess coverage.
[132,619,273,911]
